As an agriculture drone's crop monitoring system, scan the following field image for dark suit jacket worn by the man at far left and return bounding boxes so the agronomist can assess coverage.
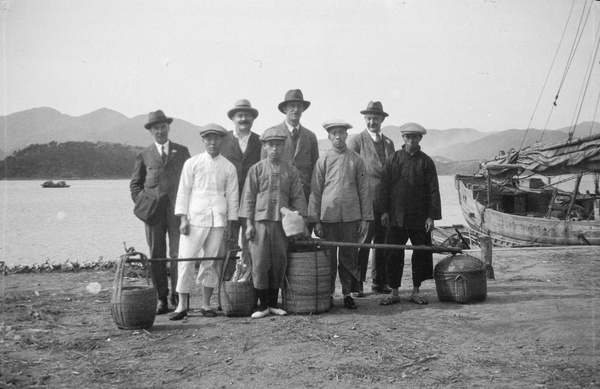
[129,142,190,212]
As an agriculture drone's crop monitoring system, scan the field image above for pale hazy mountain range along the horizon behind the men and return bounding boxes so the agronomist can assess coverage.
[0,107,600,162]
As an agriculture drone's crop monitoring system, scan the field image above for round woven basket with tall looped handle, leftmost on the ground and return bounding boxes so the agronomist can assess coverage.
[110,251,156,330]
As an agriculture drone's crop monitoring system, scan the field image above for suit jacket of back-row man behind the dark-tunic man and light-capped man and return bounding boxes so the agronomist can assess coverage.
[348,130,394,213]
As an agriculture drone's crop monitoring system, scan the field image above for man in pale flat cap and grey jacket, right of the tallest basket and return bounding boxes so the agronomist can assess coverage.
[308,119,373,309]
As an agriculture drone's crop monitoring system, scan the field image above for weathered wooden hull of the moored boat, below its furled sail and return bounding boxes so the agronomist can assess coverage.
[455,175,600,246]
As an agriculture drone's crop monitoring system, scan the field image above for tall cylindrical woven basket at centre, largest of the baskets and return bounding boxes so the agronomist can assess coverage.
[282,250,331,314]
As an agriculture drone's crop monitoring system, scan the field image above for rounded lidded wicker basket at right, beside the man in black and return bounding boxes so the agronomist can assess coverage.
[433,254,487,304]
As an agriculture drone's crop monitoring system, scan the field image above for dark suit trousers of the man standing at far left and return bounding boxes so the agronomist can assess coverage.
[146,196,180,299]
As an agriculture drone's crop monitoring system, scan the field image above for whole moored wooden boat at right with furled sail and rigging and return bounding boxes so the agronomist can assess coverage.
[455,2,600,246]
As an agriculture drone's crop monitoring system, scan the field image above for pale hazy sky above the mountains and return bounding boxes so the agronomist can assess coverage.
[0,0,600,137]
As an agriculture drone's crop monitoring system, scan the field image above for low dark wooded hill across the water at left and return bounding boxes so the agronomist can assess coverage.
[0,142,142,181]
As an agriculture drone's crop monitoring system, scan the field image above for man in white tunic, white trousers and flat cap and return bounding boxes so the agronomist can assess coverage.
[169,123,239,320]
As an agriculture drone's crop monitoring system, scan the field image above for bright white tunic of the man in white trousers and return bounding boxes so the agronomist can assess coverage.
[175,152,239,227]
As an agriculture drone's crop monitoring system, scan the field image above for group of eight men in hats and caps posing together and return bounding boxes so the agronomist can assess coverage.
[130,89,441,320]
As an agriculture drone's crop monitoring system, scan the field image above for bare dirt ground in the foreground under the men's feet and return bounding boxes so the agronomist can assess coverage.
[0,248,600,389]
